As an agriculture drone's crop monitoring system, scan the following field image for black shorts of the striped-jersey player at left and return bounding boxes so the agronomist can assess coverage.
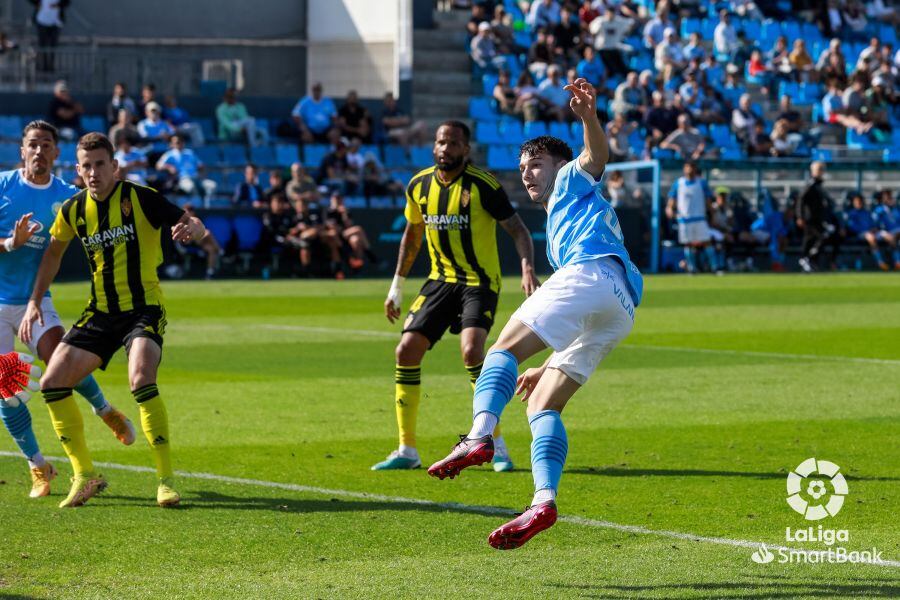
[63,305,166,369]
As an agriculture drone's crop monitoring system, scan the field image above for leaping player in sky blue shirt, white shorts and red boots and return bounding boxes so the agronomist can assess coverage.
[428,79,643,550]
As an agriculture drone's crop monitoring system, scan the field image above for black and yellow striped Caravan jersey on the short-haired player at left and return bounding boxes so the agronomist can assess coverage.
[50,181,184,313]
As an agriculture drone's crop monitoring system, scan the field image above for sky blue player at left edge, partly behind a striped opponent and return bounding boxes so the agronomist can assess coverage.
[0,121,135,498]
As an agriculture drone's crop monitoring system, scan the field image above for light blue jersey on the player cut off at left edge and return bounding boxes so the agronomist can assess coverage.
[0,170,79,304]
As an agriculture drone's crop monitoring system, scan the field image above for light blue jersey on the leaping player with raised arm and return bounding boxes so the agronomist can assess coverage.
[547,158,644,306]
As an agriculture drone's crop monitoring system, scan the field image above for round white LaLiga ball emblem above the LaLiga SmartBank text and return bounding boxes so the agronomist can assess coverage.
[787,458,848,521]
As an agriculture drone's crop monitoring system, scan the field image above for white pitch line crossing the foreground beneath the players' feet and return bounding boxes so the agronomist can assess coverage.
[0,450,900,567]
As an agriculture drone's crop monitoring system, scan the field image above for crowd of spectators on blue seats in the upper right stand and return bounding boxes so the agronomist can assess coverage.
[467,0,900,160]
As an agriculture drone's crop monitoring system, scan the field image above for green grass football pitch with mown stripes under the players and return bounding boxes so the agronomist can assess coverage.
[0,274,900,599]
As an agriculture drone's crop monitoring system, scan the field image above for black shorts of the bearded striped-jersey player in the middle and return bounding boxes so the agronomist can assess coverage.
[403,279,497,346]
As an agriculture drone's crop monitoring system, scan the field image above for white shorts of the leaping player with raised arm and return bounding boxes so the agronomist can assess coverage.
[512,257,634,385]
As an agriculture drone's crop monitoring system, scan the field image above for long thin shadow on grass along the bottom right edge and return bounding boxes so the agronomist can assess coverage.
[546,579,900,600]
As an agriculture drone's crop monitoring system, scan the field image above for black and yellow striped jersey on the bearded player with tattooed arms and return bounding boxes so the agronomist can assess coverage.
[405,164,516,291]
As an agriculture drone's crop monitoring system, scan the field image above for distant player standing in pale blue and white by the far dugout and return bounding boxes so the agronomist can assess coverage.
[666,161,723,273]
